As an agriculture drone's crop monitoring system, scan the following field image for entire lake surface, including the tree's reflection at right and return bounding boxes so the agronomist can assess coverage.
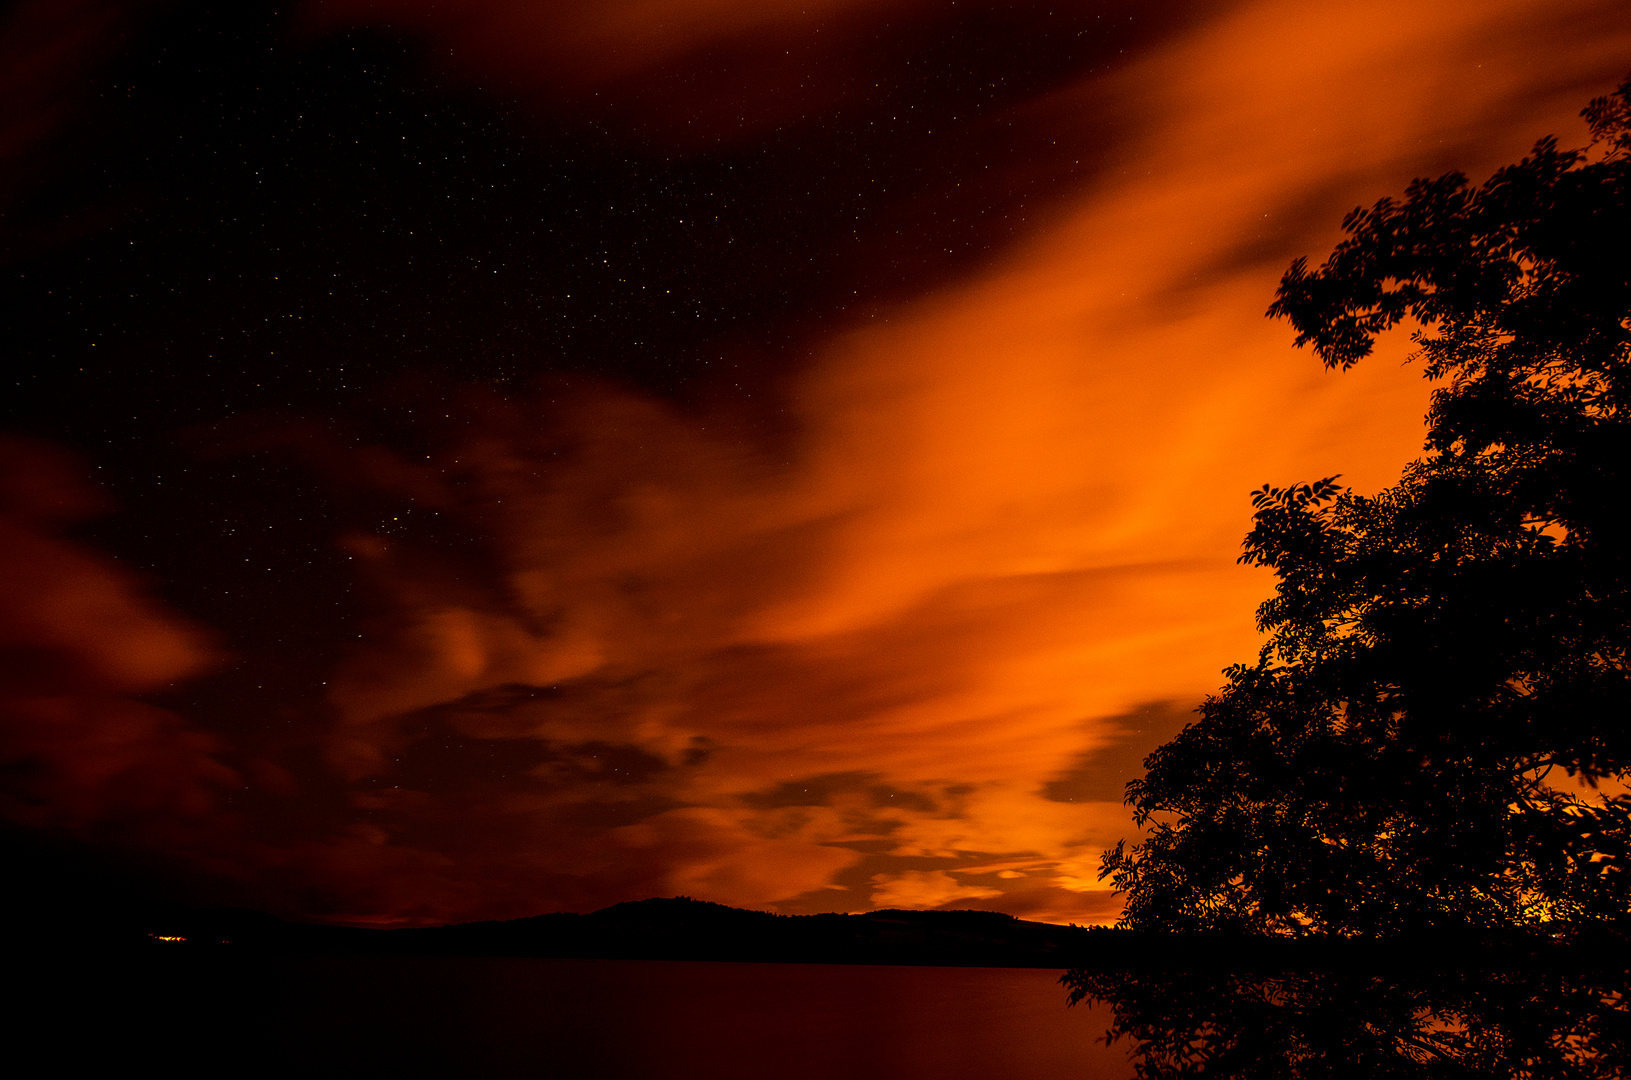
[35,946,1631,1080]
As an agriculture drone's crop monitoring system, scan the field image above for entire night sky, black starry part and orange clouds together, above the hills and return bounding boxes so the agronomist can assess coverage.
[0,0,1631,925]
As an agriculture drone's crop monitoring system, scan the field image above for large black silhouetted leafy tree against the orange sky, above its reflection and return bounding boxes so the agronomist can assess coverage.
[1103,78,1631,935]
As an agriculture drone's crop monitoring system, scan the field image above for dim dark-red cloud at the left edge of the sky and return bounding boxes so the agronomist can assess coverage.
[0,437,236,847]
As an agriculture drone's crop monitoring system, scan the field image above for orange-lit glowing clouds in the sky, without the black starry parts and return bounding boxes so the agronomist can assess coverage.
[7,0,1631,922]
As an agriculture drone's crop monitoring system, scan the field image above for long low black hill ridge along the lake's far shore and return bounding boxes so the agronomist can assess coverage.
[123,897,1631,972]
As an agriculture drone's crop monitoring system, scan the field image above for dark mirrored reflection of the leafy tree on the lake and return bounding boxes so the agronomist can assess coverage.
[1063,969,1631,1080]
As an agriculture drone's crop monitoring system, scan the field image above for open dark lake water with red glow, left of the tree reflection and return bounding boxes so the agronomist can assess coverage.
[59,956,1132,1080]
